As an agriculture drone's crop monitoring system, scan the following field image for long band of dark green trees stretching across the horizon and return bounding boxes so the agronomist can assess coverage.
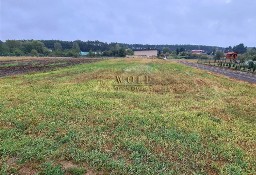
[0,40,252,57]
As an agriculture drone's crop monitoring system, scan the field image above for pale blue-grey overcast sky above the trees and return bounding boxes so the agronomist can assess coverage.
[0,0,256,46]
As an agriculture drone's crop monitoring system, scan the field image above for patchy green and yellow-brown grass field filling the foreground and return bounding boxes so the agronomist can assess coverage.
[0,59,256,175]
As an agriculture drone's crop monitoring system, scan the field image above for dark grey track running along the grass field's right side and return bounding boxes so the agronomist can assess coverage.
[179,61,256,84]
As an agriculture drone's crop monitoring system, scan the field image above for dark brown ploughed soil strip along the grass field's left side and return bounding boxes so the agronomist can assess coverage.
[0,58,102,77]
